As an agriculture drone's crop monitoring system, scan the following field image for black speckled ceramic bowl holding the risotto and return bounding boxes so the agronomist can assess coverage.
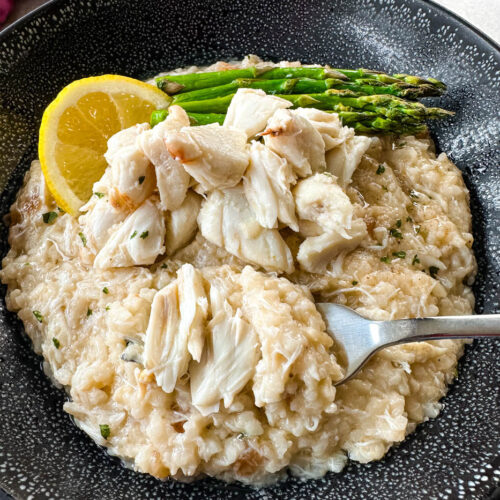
[0,0,500,500]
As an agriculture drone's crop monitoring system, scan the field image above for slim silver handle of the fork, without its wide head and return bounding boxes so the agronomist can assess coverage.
[390,314,500,342]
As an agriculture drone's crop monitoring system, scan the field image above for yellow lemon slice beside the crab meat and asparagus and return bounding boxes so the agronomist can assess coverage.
[38,75,171,215]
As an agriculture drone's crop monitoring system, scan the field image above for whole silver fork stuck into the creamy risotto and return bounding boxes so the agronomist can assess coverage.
[316,303,500,385]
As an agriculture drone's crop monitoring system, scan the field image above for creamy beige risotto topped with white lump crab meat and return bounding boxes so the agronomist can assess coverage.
[1,59,476,485]
